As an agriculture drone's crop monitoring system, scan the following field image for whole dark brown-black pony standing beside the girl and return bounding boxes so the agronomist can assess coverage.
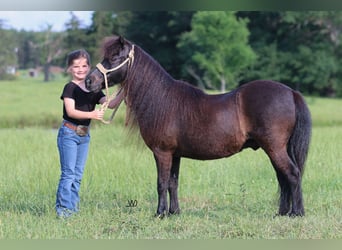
[86,36,311,216]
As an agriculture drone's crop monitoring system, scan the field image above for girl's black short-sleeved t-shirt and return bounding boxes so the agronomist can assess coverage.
[61,82,105,126]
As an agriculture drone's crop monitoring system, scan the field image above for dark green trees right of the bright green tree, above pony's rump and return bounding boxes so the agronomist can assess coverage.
[238,11,342,96]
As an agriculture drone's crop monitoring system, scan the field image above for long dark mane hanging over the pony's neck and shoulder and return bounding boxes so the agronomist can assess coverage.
[124,45,206,137]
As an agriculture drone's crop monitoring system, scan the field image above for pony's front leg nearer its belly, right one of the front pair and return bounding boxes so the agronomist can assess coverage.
[169,157,180,214]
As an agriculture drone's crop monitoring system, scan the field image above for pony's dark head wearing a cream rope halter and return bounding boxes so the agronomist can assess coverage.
[85,36,134,92]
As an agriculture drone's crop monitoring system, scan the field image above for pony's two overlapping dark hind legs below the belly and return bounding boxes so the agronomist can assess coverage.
[268,150,304,216]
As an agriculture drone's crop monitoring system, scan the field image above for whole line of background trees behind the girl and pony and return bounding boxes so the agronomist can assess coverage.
[0,11,342,97]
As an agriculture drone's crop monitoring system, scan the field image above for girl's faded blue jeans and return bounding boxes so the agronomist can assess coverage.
[56,120,90,216]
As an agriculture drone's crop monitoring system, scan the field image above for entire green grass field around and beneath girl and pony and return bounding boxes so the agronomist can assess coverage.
[0,79,342,239]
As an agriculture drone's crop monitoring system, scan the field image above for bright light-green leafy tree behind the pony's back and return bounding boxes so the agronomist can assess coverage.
[178,11,255,92]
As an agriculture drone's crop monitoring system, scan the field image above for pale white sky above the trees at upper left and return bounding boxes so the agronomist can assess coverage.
[0,11,93,31]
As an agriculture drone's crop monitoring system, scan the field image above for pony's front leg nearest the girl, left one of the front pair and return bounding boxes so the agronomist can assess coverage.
[154,150,172,217]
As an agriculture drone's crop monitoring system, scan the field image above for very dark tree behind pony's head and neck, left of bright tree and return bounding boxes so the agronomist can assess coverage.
[115,11,194,78]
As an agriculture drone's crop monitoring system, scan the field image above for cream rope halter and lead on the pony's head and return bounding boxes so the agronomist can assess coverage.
[96,45,134,124]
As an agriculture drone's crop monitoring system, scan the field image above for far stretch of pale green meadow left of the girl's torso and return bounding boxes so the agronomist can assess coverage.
[0,78,67,128]
